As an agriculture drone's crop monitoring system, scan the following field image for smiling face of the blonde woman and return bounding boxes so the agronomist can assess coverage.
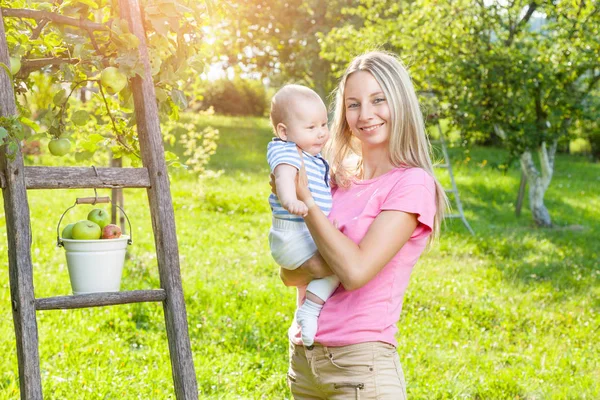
[344,71,392,147]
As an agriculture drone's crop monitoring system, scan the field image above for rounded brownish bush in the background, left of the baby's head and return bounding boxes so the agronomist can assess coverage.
[200,78,267,117]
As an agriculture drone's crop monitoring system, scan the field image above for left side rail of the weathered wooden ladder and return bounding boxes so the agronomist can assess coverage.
[0,10,42,400]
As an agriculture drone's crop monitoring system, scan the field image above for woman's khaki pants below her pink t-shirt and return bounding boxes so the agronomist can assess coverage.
[288,342,406,400]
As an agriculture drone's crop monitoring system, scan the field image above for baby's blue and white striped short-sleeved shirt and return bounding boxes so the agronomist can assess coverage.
[267,138,332,222]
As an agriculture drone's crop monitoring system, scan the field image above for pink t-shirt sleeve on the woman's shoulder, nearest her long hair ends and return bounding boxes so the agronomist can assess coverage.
[381,175,436,237]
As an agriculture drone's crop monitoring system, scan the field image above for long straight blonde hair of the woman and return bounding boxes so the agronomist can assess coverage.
[326,51,448,243]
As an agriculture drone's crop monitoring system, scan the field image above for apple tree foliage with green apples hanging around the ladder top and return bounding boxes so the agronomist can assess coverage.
[0,0,221,170]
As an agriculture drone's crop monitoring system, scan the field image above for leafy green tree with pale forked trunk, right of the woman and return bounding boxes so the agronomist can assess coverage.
[323,0,600,226]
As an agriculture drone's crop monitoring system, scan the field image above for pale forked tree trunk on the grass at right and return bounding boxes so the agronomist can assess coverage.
[520,140,558,227]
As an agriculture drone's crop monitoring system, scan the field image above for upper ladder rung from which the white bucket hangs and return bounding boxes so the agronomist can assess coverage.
[0,167,150,189]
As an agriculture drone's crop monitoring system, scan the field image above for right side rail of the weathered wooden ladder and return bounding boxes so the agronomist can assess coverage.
[119,0,198,400]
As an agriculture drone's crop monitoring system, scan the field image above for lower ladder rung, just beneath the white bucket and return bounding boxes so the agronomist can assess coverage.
[35,289,167,310]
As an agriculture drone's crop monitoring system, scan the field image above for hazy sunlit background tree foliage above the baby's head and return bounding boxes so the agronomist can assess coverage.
[213,0,358,98]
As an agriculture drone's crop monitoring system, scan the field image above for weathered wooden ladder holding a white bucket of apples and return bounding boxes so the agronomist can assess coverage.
[0,0,198,400]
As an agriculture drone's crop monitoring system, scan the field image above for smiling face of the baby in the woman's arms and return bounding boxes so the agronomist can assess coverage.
[283,98,329,156]
